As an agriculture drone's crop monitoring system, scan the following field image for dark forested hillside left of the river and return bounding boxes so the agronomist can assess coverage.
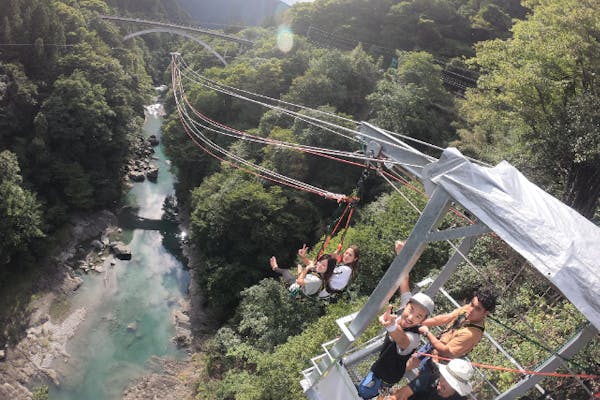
[0,0,186,343]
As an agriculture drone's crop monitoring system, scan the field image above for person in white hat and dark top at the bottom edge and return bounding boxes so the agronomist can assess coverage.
[385,358,473,400]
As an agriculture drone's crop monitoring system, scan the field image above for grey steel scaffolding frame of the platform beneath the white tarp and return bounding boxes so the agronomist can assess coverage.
[301,123,598,400]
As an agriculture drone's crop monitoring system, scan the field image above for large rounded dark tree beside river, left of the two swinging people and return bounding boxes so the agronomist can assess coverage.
[190,169,313,317]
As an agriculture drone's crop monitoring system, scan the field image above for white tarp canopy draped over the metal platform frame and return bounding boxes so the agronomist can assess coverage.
[423,148,600,330]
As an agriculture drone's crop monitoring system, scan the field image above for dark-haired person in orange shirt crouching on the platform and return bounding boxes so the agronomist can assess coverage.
[406,288,497,382]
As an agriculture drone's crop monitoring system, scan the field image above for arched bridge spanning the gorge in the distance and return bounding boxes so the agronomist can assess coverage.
[100,15,254,65]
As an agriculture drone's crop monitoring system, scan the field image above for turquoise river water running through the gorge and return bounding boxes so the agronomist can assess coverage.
[49,104,189,400]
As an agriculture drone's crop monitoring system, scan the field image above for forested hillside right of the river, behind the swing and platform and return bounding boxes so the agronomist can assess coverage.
[159,0,600,399]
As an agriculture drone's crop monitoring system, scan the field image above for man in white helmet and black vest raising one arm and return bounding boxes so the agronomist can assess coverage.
[357,242,434,399]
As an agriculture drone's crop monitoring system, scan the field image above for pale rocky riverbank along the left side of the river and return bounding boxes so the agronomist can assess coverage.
[0,211,116,400]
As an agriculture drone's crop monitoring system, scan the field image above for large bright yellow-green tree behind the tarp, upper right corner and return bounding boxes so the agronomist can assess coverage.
[454,0,600,218]
